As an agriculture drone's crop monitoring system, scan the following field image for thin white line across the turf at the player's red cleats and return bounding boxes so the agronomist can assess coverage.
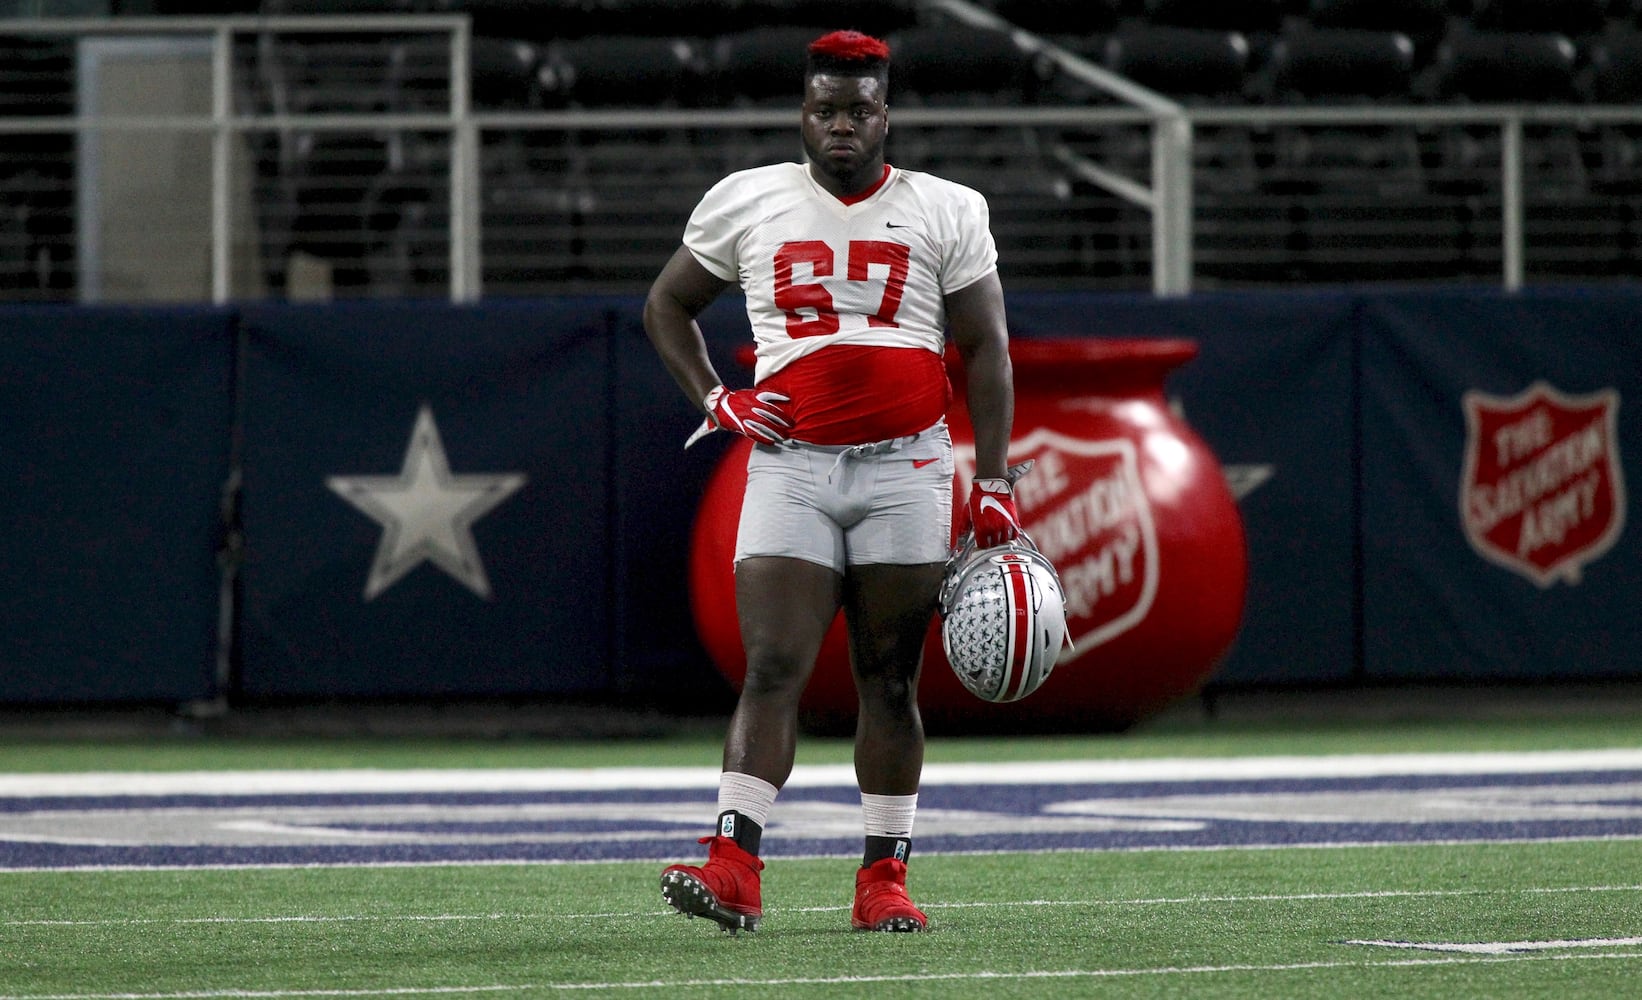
[0,885,1642,926]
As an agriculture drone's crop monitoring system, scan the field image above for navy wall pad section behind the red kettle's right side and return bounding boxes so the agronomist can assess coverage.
[1008,292,1356,683]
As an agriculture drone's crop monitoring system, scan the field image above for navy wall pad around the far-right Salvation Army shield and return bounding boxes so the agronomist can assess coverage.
[1363,289,1642,680]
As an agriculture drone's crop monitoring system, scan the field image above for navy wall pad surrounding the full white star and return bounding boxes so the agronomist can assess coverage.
[241,300,612,696]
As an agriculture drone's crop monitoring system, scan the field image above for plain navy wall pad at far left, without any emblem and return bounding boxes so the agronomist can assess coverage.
[0,307,233,703]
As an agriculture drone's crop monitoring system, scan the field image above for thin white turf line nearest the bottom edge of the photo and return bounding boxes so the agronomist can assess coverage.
[0,951,1642,1000]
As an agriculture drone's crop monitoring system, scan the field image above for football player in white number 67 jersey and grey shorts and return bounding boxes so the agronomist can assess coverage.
[644,31,1018,931]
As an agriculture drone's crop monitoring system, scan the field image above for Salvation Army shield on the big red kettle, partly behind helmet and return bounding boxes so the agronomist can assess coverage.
[959,427,1158,663]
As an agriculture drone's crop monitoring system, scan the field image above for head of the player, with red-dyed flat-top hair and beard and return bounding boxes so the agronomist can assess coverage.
[803,31,890,190]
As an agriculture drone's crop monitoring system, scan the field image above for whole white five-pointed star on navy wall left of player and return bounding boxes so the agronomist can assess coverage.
[325,404,525,601]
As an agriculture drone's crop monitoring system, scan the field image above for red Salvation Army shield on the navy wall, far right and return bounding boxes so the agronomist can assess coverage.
[1460,383,1626,586]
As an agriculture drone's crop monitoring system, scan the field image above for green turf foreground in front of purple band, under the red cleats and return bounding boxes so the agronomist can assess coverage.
[0,841,1642,1000]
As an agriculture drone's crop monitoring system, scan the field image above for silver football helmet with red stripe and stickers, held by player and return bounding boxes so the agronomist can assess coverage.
[941,534,1069,703]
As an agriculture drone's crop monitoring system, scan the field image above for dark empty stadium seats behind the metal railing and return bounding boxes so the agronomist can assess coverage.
[0,0,1642,299]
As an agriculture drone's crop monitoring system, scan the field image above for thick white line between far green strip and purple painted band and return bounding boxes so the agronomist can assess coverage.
[0,749,1642,798]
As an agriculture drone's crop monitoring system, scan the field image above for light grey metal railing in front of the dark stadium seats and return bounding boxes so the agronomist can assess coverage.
[0,11,1642,302]
